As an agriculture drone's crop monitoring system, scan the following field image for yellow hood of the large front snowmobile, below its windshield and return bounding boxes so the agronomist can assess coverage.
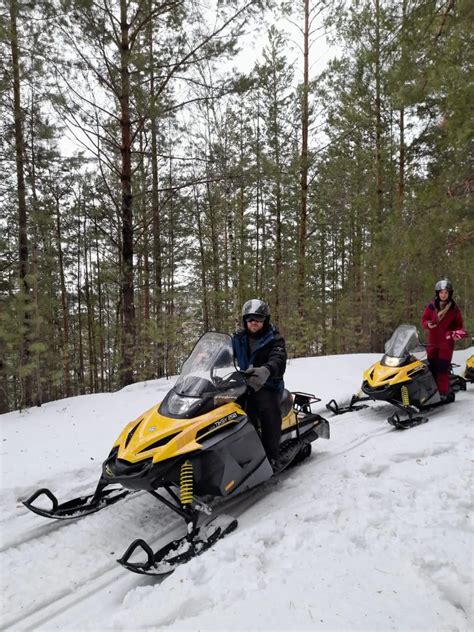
[114,402,245,463]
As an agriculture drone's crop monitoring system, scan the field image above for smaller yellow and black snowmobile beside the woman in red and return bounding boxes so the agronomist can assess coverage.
[326,325,466,429]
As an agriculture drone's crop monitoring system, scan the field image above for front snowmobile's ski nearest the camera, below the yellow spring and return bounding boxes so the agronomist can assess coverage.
[117,514,238,575]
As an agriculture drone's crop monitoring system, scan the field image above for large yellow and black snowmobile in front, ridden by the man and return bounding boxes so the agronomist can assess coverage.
[24,332,329,575]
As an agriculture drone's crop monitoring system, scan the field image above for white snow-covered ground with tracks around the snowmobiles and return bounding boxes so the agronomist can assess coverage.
[0,348,474,632]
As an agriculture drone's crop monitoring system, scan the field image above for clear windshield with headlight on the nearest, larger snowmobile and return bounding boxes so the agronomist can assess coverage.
[160,331,246,417]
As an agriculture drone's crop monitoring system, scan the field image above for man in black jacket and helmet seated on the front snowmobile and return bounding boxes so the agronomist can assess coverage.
[232,299,286,470]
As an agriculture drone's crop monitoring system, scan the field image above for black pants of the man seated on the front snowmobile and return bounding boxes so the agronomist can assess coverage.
[247,388,281,459]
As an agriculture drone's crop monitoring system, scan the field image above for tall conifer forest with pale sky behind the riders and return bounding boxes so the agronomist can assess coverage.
[0,0,474,412]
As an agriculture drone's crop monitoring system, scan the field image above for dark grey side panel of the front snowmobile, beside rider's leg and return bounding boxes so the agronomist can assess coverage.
[192,420,272,496]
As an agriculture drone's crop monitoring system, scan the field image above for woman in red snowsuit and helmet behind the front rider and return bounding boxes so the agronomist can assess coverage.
[421,279,466,401]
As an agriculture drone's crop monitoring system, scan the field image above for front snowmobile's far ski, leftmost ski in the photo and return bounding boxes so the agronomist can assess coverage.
[23,484,132,520]
